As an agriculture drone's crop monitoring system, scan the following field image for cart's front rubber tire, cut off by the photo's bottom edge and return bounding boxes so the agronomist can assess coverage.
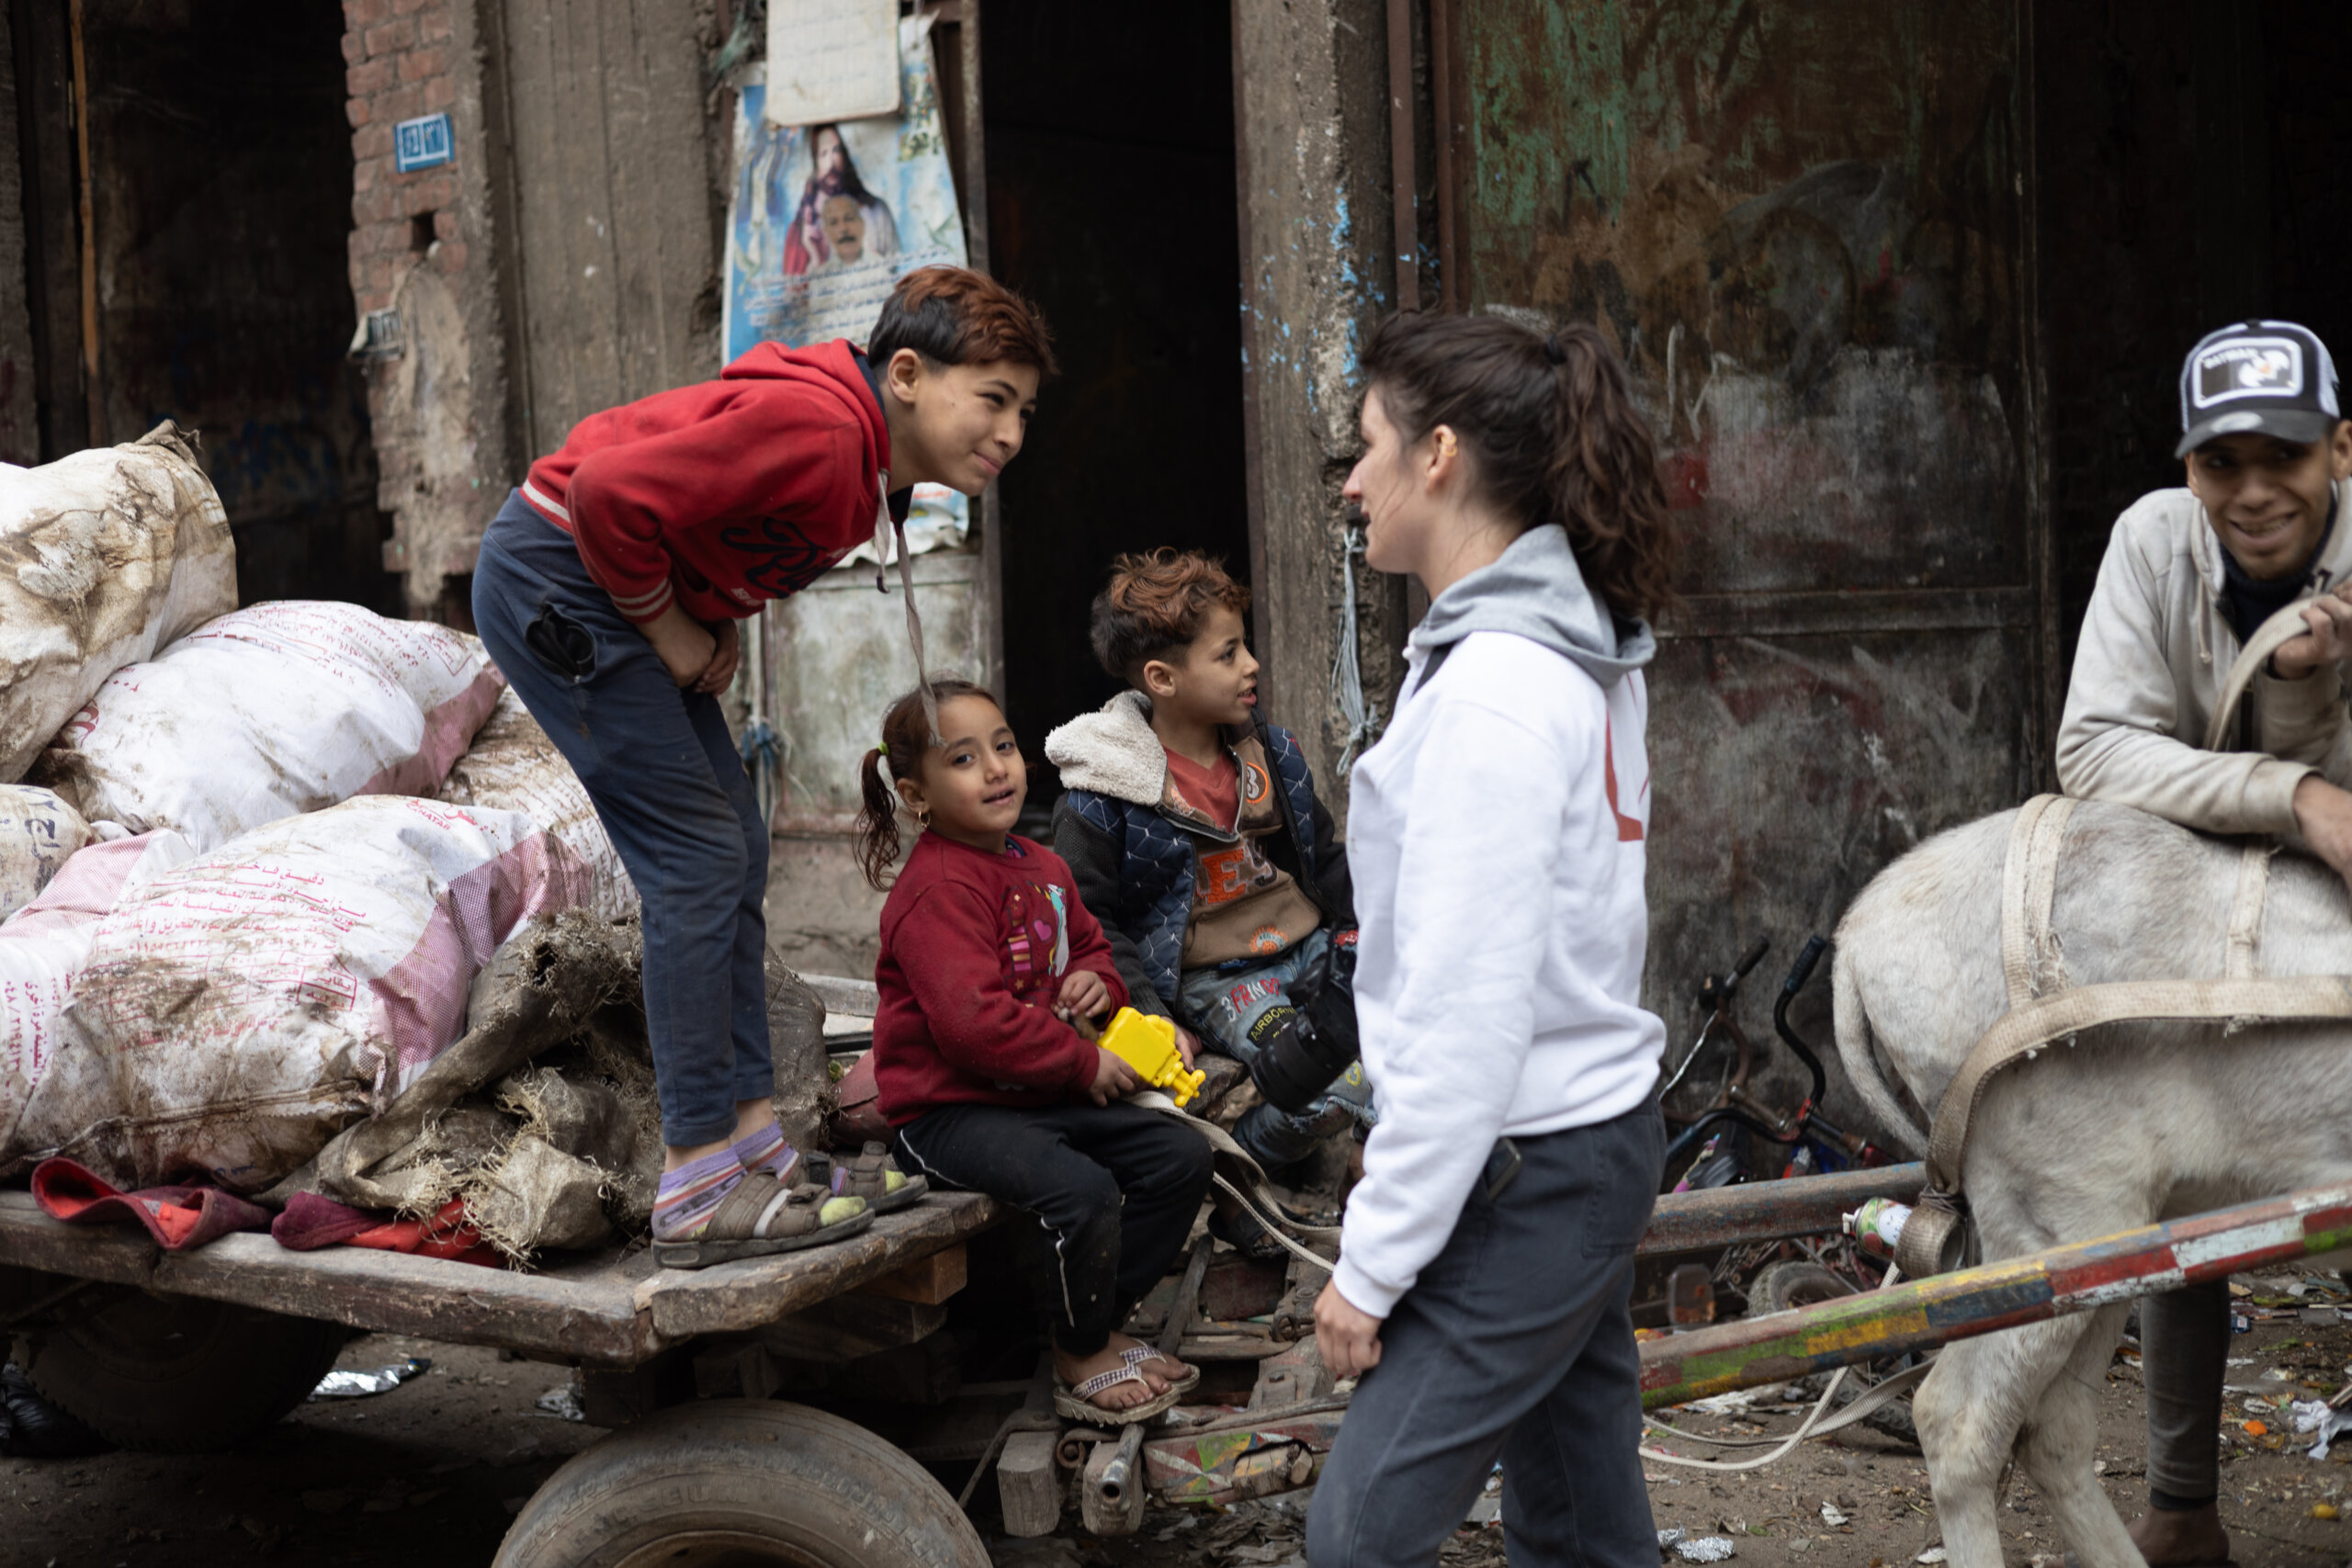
[492,1399,988,1568]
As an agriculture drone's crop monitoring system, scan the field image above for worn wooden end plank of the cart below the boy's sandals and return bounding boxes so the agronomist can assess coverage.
[638,1192,1004,1340]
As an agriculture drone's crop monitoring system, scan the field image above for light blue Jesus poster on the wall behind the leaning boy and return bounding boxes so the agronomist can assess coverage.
[727,9,969,549]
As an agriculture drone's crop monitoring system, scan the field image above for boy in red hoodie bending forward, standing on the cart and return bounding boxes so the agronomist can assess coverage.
[473,268,1054,1267]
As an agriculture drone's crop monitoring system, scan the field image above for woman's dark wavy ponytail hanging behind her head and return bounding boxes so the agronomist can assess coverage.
[1543,322,1675,618]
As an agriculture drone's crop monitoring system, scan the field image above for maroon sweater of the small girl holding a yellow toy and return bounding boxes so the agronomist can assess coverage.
[875,832,1126,1126]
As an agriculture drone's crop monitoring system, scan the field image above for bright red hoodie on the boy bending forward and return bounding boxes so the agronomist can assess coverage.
[522,341,889,626]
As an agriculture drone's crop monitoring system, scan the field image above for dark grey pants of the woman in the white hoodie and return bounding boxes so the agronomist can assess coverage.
[1307,1102,1665,1568]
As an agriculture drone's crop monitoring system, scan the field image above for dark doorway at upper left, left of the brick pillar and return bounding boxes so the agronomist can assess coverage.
[7,0,400,614]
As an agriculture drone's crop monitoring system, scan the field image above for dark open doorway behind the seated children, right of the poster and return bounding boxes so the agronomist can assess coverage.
[981,0,1282,832]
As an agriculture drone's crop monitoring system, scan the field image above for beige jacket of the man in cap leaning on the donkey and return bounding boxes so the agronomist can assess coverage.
[2058,479,2352,835]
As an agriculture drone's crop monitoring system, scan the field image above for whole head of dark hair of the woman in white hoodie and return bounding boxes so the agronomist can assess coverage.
[1364,310,1675,618]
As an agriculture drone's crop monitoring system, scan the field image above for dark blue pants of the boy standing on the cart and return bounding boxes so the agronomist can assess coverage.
[473,496,776,1145]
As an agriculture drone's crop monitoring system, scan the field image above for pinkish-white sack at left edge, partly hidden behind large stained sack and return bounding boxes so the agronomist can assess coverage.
[0,832,195,1149]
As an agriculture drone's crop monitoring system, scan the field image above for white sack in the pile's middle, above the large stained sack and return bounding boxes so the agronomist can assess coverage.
[33,600,505,853]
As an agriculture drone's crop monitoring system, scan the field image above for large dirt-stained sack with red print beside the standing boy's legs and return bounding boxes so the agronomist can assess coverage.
[7,797,593,1192]
